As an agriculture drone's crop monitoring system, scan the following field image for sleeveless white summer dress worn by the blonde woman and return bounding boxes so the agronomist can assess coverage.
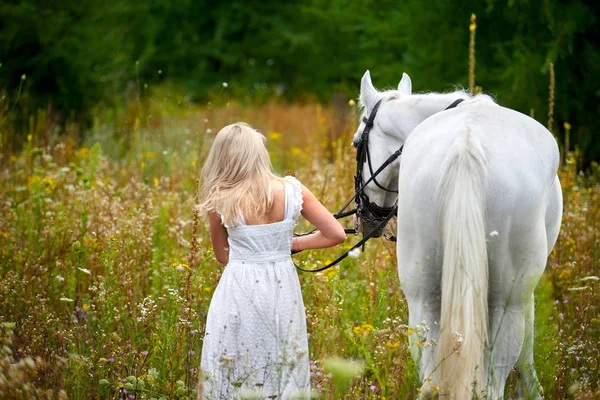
[199,177,310,399]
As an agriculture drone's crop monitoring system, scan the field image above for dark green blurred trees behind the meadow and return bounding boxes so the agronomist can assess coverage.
[0,0,600,164]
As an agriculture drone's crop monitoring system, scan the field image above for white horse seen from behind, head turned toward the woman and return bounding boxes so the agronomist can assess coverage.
[354,71,562,400]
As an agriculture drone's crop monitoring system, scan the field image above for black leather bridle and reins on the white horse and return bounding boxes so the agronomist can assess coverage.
[293,99,464,272]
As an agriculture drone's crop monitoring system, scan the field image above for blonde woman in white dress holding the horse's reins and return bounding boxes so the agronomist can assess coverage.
[200,123,346,399]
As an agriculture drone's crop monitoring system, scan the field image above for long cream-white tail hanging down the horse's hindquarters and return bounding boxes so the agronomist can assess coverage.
[434,127,488,399]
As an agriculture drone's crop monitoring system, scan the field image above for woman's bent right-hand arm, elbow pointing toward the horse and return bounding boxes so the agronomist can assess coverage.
[292,185,346,252]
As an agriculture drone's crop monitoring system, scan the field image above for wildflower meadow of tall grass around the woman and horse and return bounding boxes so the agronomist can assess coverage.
[0,91,600,399]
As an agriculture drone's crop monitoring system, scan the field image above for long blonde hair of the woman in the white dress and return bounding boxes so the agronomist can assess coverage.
[199,122,281,226]
